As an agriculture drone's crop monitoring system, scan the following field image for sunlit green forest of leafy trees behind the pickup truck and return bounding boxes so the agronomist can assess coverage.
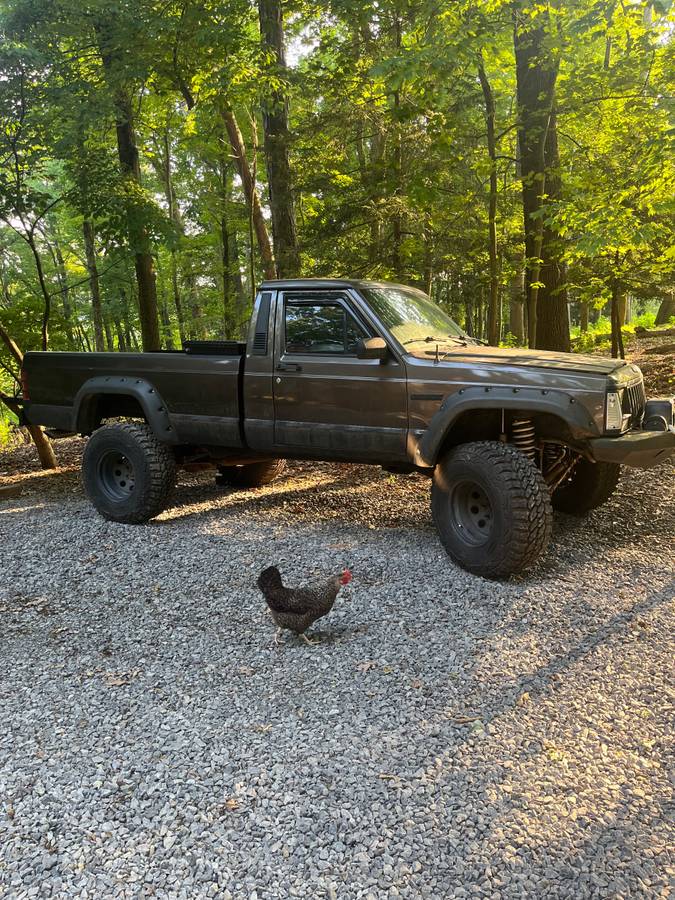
[0,0,675,432]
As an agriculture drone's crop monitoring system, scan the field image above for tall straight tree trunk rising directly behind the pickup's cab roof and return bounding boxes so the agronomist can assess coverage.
[258,0,300,278]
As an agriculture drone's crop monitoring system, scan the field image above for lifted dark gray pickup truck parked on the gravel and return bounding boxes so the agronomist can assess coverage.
[18,279,675,578]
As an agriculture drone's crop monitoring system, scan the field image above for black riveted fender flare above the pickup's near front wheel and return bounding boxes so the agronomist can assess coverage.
[415,386,598,468]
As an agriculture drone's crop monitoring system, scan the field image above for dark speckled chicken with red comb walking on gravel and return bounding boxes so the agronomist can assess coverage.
[258,566,352,644]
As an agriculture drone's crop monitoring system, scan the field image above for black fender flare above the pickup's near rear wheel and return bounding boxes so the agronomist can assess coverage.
[73,375,176,444]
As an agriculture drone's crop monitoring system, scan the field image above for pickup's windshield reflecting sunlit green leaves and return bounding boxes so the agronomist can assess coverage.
[363,285,464,344]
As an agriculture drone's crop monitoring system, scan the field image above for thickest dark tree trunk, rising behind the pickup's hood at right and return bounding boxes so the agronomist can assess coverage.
[513,2,569,350]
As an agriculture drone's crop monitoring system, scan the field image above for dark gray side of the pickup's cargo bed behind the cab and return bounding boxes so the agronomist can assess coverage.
[24,341,246,447]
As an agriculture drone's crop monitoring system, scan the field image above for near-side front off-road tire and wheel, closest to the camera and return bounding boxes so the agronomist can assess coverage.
[431,441,553,579]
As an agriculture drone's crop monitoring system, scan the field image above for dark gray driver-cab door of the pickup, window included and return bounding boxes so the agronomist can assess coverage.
[273,290,408,462]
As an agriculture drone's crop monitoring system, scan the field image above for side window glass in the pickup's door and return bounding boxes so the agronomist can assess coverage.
[285,301,367,355]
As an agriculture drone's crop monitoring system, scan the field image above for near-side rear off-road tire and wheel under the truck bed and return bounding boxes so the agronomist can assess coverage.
[82,422,176,525]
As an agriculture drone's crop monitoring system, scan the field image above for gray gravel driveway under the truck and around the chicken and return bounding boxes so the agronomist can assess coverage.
[0,458,675,900]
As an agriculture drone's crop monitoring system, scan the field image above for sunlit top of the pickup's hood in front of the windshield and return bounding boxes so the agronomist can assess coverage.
[411,344,640,380]
